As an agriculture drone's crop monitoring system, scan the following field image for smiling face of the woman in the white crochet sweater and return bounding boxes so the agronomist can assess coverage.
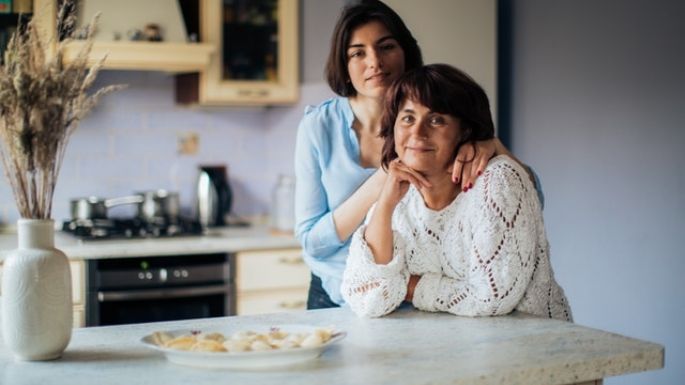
[395,100,461,175]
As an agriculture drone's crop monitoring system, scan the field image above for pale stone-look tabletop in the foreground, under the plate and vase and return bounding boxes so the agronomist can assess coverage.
[0,308,664,385]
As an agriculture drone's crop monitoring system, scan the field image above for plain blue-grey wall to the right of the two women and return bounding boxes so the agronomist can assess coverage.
[510,0,685,385]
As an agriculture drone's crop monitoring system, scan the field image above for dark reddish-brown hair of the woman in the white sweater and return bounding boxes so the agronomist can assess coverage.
[380,64,495,169]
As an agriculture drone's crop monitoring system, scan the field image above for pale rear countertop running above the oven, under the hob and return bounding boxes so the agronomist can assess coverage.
[0,225,300,261]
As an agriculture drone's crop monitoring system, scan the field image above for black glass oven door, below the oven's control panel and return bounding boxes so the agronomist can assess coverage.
[86,284,233,326]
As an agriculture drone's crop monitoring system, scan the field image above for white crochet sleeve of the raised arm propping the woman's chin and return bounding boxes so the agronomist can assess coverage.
[341,220,409,317]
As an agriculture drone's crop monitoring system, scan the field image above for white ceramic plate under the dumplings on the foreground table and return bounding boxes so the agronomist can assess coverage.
[141,325,347,370]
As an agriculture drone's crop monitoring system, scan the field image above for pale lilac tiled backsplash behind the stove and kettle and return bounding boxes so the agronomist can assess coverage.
[0,71,332,224]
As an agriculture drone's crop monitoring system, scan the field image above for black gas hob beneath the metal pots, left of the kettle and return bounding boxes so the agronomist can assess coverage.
[62,218,202,240]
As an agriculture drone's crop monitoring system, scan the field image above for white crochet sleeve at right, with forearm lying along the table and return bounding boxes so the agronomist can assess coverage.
[413,158,540,316]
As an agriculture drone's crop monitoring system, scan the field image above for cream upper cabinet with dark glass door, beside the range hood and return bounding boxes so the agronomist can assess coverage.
[176,0,299,105]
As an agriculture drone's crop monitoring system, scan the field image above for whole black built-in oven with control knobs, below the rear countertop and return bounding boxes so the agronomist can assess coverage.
[86,253,236,326]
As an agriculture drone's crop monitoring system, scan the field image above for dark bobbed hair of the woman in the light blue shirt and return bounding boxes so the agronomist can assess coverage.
[325,0,423,96]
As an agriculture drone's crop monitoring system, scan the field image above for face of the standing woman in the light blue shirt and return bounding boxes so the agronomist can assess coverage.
[347,21,404,98]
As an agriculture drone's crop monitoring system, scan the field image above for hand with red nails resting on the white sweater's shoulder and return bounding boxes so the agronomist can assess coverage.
[448,138,499,192]
